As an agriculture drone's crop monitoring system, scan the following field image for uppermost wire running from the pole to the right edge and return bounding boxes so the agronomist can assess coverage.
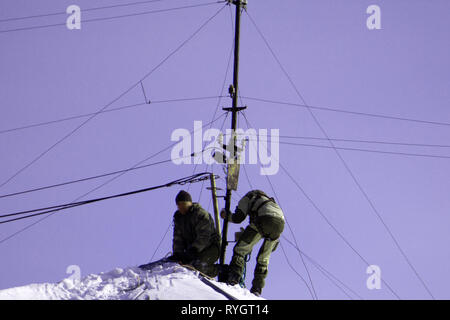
[244,96,450,126]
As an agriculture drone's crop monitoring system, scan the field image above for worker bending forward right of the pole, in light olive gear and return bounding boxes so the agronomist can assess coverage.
[221,190,285,295]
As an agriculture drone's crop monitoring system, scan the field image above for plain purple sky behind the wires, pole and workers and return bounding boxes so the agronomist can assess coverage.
[0,0,450,299]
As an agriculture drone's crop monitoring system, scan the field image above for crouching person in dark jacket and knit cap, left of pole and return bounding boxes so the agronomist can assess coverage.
[170,190,220,277]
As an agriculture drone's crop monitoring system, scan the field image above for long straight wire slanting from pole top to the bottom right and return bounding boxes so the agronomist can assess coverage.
[246,12,434,299]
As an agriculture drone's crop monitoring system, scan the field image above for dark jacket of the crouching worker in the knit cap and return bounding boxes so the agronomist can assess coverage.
[172,202,220,254]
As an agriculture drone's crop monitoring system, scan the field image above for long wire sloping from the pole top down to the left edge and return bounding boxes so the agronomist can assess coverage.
[0,6,225,188]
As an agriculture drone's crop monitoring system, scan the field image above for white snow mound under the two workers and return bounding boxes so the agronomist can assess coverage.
[0,262,262,300]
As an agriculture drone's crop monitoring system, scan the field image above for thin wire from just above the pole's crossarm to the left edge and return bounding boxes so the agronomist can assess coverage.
[0,96,225,134]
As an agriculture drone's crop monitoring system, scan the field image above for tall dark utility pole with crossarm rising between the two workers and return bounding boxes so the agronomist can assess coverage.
[219,0,247,281]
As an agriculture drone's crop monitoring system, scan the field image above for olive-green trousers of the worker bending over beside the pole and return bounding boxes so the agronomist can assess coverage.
[230,217,284,289]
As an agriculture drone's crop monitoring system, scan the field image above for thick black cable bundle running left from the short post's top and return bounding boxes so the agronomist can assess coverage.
[0,172,214,224]
